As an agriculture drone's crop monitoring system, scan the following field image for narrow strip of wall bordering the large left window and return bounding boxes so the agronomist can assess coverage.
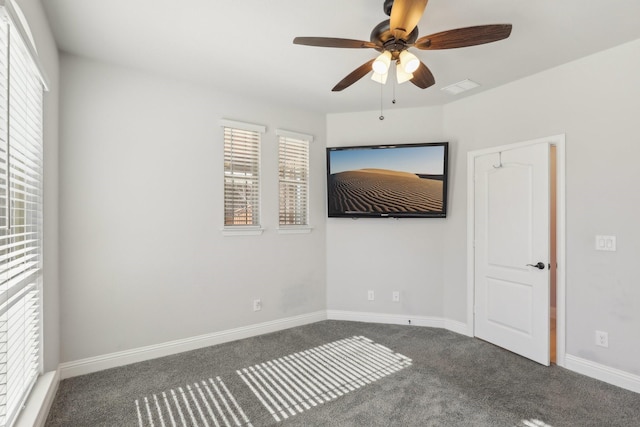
[16,0,60,371]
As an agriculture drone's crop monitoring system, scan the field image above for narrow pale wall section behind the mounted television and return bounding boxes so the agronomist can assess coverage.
[327,107,447,317]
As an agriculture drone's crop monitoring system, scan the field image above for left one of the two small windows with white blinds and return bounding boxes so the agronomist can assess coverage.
[222,120,265,227]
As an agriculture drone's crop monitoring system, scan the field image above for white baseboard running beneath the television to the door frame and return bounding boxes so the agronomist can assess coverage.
[327,310,468,335]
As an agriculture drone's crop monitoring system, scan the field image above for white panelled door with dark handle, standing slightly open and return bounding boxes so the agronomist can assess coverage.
[474,142,550,365]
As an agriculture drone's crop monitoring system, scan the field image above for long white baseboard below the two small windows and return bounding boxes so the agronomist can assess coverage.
[59,311,327,379]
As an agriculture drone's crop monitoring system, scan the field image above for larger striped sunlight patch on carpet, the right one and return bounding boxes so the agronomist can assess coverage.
[237,336,411,422]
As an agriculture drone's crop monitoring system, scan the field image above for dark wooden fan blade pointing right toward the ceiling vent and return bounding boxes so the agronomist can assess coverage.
[414,24,512,50]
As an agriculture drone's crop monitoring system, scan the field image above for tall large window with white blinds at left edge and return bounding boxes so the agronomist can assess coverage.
[0,2,44,427]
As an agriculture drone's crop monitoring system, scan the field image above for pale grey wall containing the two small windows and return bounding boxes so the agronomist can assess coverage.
[60,54,326,362]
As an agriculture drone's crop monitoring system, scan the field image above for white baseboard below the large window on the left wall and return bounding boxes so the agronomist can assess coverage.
[15,370,60,427]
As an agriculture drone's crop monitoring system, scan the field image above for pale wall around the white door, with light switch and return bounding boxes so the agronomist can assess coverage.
[444,40,640,375]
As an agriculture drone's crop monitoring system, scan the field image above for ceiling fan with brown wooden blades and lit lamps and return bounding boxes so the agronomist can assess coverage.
[293,0,511,92]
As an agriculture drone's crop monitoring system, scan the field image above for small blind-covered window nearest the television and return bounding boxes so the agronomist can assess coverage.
[276,129,313,226]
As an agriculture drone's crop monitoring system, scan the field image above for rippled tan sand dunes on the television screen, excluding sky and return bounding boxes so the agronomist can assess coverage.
[329,169,443,214]
